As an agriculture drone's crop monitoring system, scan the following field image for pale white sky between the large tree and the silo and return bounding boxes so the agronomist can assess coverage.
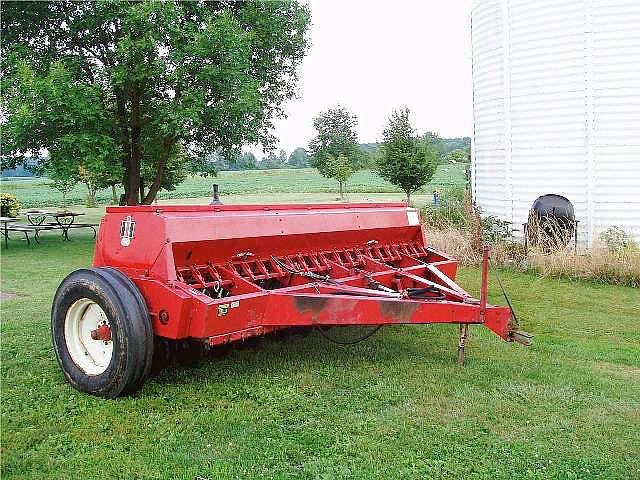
[258,0,472,153]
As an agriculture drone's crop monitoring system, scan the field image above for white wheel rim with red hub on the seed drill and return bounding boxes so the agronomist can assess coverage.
[64,298,113,375]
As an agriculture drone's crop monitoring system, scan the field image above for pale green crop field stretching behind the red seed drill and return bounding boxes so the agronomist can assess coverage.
[0,165,464,208]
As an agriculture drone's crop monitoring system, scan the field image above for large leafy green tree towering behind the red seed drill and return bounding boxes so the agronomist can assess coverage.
[1,1,310,204]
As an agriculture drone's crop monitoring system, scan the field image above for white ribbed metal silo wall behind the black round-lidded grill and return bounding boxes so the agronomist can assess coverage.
[472,0,640,243]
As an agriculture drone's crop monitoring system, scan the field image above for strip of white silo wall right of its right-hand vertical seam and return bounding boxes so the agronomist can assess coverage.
[589,0,640,239]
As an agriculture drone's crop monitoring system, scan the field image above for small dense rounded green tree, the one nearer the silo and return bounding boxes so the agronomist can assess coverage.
[377,108,437,203]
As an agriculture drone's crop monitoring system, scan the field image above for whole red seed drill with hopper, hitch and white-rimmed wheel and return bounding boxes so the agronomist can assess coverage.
[52,203,530,397]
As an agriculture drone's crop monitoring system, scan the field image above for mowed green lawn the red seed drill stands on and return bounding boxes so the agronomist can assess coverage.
[0,224,640,480]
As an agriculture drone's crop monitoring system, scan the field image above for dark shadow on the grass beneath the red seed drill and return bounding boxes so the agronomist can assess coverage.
[145,325,457,395]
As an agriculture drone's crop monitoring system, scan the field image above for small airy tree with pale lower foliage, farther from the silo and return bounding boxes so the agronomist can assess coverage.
[309,105,364,194]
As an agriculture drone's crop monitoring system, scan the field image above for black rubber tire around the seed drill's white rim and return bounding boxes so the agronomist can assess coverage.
[51,268,153,398]
